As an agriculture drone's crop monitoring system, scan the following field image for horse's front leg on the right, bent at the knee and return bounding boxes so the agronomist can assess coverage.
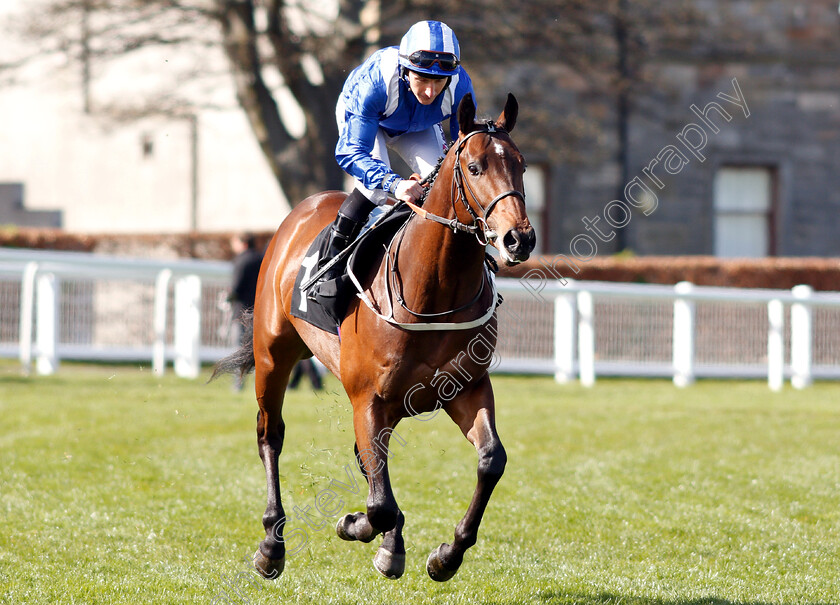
[426,374,507,582]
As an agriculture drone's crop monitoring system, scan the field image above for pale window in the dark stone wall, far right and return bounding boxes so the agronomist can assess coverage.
[714,166,774,258]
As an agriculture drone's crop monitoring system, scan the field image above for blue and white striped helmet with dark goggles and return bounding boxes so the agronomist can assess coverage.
[400,21,461,77]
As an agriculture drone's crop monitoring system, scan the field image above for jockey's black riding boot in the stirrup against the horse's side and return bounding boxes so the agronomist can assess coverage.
[309,189,376,300]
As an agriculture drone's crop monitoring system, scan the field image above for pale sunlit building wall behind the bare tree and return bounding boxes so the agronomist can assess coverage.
[0,0,289,233]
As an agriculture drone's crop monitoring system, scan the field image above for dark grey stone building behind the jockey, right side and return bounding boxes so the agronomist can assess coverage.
[389,0,840,260]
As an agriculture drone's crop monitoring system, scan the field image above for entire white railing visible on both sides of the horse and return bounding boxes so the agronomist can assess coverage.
[0,249,840,390]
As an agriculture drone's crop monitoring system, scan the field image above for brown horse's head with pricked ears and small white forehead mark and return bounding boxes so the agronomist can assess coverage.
[455,94,536,265]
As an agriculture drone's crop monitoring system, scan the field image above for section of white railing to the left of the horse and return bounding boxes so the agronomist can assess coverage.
[0,249,232,377]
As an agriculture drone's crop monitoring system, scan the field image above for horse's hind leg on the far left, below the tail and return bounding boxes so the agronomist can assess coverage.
[254,324,304,580]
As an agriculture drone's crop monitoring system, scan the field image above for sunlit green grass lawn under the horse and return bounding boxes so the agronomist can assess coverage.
[0,361,840,605]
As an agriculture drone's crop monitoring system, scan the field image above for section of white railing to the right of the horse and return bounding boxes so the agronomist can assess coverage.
[499,280,840,390]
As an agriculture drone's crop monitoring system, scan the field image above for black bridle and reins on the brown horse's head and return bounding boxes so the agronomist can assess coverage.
[406,121,525,246]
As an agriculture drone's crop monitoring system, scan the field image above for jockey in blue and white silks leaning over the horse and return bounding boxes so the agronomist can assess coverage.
[314,21,475,296]
